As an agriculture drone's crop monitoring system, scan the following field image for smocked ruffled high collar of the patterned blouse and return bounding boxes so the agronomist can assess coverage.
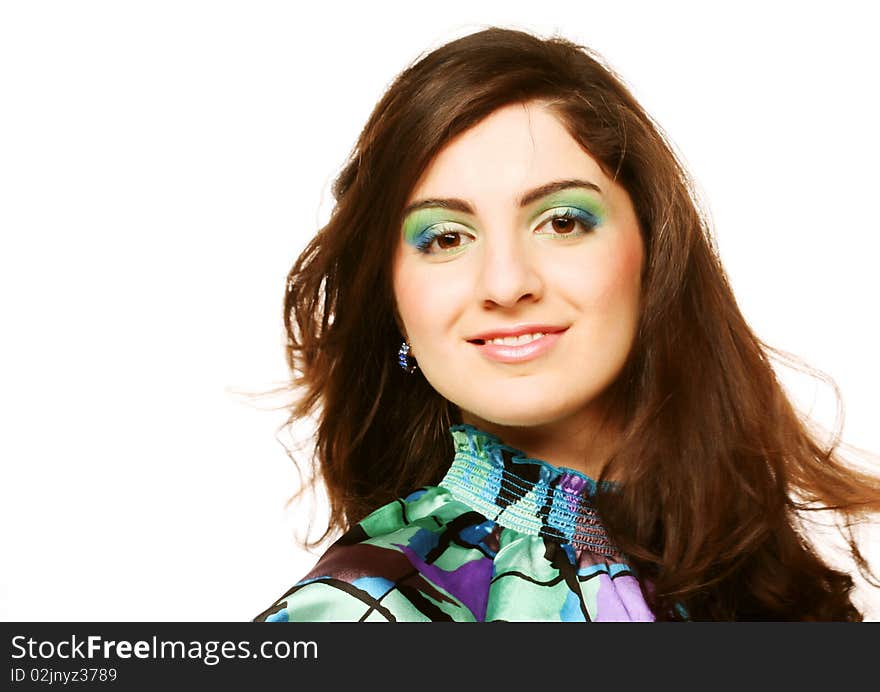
[440,423,619,556]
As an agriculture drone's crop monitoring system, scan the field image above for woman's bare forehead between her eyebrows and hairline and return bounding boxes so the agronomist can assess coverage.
[407,102,608,205]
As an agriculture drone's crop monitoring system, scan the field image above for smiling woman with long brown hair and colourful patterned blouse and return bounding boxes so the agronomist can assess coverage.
[256,28,880,621]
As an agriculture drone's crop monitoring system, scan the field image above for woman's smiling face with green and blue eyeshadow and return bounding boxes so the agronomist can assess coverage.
[393,102,644,426]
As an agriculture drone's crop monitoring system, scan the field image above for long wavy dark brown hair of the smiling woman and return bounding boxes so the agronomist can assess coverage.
[264,27,880,620]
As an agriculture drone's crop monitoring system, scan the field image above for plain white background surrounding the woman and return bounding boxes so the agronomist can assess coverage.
[0,0,880,621]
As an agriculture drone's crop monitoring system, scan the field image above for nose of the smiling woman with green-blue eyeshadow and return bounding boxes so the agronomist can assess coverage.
[477,233,544,307]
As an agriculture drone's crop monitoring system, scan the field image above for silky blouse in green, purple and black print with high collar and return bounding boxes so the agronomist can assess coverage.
[255,425,654,622]
